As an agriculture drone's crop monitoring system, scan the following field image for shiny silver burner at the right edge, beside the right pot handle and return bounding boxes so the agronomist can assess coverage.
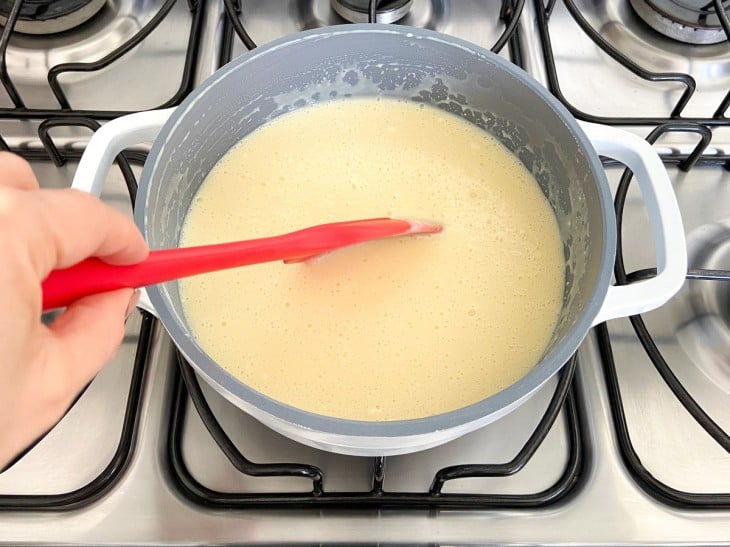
[677,220,730,394]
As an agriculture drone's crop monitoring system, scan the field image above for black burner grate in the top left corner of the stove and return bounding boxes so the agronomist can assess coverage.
[0,0,205,120]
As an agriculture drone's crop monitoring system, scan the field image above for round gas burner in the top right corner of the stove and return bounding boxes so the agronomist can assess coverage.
[631,0,730,44]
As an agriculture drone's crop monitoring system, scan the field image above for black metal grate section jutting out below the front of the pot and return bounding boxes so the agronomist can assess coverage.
[167,354,585,510]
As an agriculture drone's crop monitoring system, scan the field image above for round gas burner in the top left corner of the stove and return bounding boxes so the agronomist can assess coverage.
[0,0,106,34]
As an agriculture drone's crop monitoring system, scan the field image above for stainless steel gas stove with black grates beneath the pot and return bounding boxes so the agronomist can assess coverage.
[0,0,730,545]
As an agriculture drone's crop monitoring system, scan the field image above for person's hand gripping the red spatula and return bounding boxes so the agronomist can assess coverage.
[0,152,148,470]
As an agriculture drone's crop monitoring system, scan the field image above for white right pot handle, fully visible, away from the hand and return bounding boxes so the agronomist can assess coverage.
[578,122,687,325]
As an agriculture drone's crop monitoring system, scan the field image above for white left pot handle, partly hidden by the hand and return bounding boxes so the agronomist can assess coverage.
[71,108,175,316]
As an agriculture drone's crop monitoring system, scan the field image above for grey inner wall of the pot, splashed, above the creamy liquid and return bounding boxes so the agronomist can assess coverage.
[138,25,614,428]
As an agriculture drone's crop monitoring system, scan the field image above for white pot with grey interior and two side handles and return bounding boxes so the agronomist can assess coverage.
[74,24,686,455]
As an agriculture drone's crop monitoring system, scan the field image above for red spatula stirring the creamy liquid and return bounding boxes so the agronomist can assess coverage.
[42,218,441,311]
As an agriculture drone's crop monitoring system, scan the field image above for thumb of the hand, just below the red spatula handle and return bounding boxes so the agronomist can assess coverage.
[50,289,139,389]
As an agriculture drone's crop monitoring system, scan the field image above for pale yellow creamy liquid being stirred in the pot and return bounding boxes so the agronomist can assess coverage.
[180,99,564,420]
